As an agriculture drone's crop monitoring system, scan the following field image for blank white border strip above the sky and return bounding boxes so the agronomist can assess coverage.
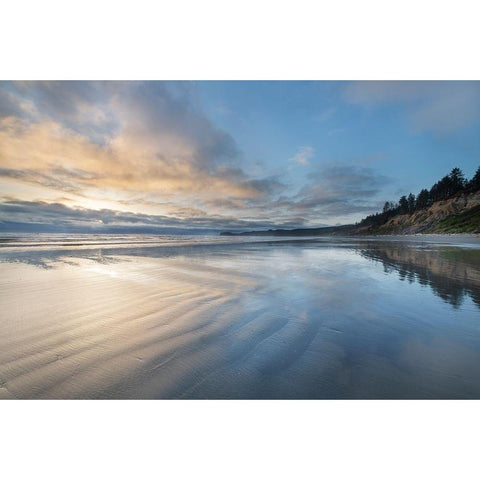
[0,0,480,80]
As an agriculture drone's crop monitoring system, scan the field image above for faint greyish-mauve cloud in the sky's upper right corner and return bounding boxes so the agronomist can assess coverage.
[343,81,480,134]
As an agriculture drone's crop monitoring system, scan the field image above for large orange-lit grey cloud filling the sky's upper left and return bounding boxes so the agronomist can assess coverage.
[0,82,280,206]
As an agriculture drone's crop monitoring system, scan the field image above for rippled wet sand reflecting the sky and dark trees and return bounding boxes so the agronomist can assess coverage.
[0,235,480,399]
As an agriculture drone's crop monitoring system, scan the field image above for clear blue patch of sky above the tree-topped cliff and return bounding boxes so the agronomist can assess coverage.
[198,82,480,195]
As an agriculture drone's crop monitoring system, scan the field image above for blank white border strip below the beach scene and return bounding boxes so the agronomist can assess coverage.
[0,401,480,480]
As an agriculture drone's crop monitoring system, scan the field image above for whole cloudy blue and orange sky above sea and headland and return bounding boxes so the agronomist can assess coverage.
[0,81,480,233]
